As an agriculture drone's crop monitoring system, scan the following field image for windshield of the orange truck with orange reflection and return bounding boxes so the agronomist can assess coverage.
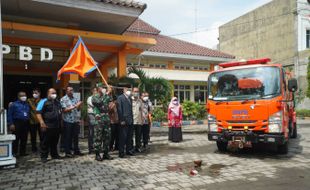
[208,67,281,101]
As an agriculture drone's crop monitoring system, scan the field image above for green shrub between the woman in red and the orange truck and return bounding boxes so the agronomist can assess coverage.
[182,101,206,120]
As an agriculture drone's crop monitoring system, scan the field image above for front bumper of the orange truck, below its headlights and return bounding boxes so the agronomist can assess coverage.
[208,131,286,144]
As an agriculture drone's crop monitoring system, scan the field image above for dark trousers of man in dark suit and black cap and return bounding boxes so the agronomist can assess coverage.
[118,125,133,154]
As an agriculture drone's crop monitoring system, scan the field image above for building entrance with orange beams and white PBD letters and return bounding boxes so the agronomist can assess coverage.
[0,0,156,108]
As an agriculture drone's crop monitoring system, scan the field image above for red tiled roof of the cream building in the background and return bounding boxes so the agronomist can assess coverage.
[124,19,235,59]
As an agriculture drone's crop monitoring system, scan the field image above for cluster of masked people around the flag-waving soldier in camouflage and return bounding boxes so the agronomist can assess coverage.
[87,84,153,161]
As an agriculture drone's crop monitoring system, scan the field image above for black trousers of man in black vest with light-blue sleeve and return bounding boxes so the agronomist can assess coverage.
[41,128,60,158]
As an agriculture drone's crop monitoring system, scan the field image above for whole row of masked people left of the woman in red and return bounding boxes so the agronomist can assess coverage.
[7,83,153,162]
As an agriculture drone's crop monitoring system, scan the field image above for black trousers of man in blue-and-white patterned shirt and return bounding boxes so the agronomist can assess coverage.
[64,122,80,154]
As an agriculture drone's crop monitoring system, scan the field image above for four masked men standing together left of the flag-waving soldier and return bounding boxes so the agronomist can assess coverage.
[7,86,83,162]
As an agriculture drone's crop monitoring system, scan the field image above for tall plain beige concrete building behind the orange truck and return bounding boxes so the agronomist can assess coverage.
[219,0,310,105]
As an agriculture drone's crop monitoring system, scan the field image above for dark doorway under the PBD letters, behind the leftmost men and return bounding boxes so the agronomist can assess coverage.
[3,75,53,109]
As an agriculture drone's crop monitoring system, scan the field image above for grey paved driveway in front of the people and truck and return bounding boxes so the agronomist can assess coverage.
[0,124,310,190]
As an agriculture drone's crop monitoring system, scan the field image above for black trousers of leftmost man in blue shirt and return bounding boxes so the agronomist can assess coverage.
[13,120,29,155]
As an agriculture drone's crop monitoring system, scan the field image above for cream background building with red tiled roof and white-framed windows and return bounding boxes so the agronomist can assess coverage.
[124,19,234,104]
